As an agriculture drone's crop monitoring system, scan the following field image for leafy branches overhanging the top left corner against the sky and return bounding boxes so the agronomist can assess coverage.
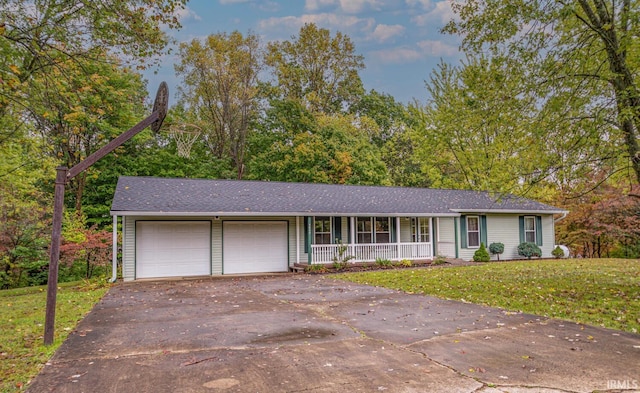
[0,0,186,143]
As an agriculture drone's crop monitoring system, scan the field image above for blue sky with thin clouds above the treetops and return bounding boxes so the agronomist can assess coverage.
[144,0,462,104]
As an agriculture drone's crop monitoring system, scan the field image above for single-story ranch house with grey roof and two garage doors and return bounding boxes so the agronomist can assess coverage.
[111,176,567,281]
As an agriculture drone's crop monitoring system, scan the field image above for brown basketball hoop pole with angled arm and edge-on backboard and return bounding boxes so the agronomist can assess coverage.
[44,82,169,345]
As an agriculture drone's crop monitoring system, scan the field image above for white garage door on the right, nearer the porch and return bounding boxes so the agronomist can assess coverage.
[222,221,288,274]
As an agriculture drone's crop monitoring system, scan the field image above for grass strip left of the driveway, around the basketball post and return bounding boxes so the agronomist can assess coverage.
[0,282,108,393]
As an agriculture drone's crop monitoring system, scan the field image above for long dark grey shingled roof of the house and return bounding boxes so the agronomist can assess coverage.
[111,176,563,216]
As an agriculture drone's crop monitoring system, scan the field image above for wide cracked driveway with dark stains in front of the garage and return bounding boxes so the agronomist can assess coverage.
[28,274,640,393]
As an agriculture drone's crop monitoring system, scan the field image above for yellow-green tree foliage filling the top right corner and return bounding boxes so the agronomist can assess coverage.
[444,0,640,184]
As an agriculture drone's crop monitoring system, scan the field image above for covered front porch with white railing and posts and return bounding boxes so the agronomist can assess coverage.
[304,216,436,264]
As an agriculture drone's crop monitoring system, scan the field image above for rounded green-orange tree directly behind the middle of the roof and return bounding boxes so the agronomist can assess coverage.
[248,101,389,184]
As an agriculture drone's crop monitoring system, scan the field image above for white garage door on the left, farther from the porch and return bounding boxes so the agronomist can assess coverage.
[136,221,211,278]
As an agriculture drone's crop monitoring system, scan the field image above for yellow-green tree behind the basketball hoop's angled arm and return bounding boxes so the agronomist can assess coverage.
[28,54,147,212]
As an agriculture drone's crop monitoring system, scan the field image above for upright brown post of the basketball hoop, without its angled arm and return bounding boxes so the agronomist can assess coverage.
[44,166,68,345]
